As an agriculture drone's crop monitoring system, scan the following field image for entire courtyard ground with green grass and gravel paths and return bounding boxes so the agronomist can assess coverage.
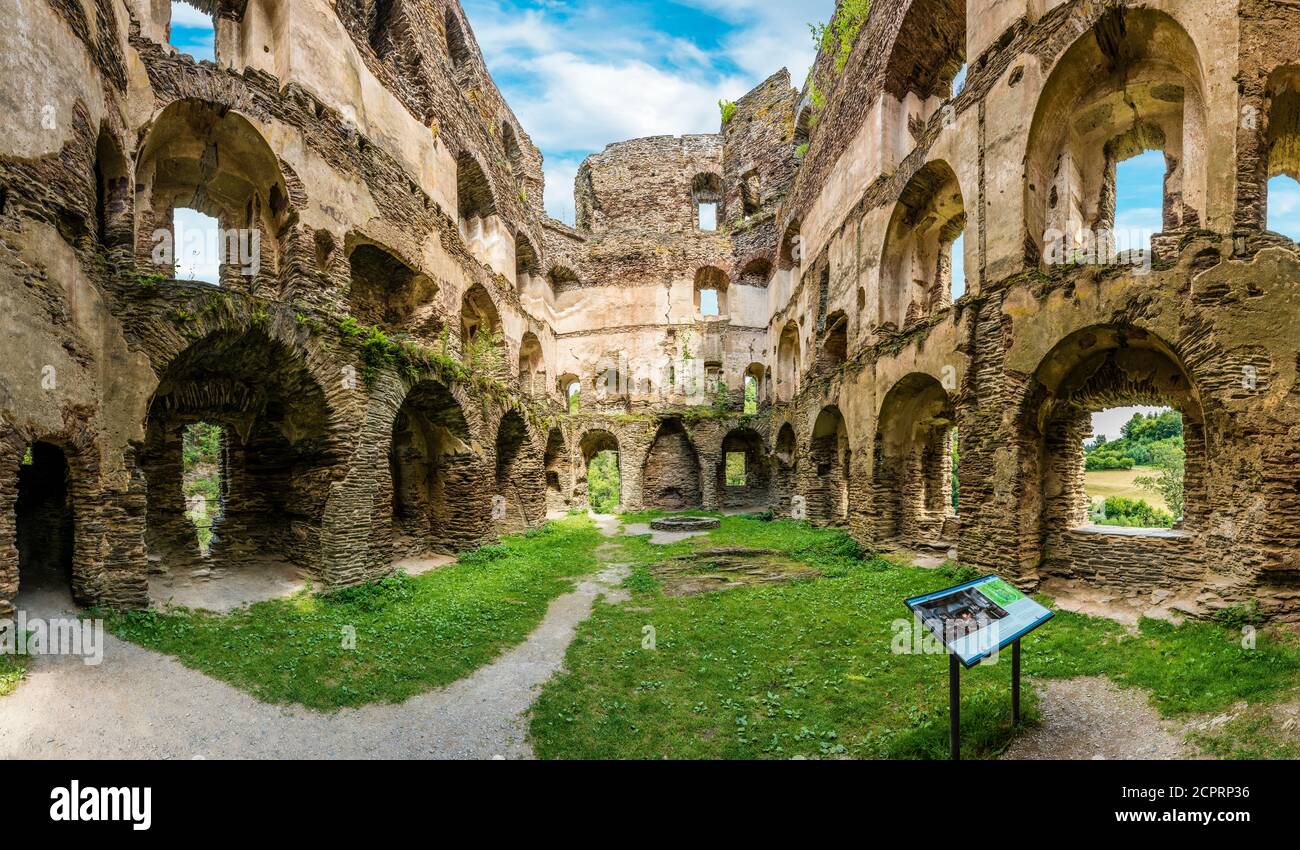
[0,513,1300,758]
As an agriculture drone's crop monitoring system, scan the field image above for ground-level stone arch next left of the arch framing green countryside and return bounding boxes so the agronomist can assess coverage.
[871,372,956,548]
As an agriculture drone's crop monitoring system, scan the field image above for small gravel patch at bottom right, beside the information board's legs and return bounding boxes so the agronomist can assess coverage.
[1002,676,1196,759]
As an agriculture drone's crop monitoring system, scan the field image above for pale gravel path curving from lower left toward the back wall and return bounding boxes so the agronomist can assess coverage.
[0,517,628,759]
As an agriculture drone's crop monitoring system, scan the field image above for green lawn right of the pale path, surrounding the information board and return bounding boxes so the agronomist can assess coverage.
[530,515,1300,759]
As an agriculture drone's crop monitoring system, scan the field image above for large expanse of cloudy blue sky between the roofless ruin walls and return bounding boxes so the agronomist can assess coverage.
[464,0,835,222]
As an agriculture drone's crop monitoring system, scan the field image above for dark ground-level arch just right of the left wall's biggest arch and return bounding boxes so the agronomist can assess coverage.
[389,380,491,558]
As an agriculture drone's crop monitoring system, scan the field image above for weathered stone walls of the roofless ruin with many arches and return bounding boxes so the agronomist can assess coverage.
[0,0,1300,626]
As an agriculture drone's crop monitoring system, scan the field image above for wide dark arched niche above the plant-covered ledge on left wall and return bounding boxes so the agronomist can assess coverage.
[347,235,445,341]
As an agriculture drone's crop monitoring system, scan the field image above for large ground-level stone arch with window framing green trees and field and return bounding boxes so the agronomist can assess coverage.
[1018,325,1210,586]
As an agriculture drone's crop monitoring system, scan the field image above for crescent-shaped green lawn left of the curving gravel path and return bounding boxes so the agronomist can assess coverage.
[100,516,602,710]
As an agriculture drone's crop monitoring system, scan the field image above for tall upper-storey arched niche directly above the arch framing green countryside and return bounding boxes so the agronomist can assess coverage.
[1024,8,1209,264]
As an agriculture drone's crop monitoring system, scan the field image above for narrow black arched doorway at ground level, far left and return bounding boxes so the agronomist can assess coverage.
[14,442,75,597]
